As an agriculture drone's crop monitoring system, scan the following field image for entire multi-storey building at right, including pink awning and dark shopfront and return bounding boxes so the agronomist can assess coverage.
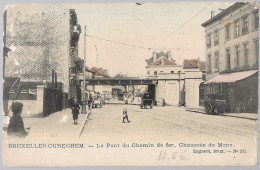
[202,2,259,112]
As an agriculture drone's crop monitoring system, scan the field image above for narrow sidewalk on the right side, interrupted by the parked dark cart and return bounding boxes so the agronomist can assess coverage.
[184,107,258,120]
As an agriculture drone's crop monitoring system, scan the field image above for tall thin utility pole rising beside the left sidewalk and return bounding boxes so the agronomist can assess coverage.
[81,26,87,114]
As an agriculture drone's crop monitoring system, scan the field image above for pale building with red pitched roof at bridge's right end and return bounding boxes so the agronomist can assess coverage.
[146,54,203,107]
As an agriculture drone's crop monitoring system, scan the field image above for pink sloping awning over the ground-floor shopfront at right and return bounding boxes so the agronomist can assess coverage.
[205,70,258,84]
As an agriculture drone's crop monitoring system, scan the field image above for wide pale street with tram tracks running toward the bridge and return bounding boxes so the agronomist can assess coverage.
[81,104,257,145]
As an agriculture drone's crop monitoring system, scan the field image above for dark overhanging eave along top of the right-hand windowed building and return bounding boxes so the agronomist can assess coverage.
[201,2,246,27]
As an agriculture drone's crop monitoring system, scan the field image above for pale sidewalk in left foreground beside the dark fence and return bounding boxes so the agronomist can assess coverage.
[2,108,89,139]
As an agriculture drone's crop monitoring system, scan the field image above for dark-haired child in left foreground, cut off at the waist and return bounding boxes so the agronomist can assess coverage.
[7,102,28,137]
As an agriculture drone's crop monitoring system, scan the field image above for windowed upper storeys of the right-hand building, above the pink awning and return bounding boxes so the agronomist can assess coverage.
[202,2,259,80]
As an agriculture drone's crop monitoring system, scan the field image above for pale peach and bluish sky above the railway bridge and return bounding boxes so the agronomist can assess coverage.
[63,2,234,77]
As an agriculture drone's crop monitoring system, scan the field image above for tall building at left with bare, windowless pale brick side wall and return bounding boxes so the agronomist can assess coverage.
[4,4,81,114]
